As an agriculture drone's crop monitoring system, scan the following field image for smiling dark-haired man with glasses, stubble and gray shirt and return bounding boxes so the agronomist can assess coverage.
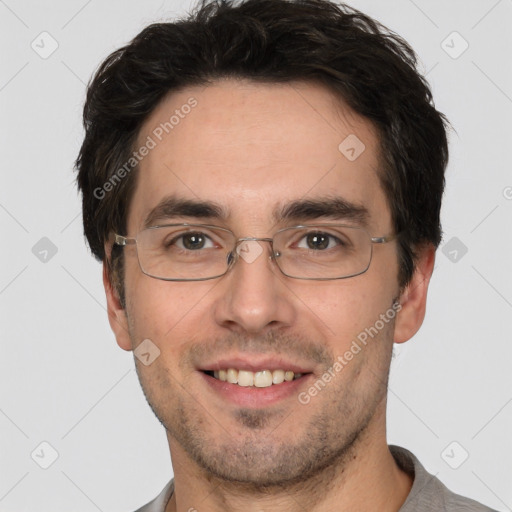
[77,0,496,512]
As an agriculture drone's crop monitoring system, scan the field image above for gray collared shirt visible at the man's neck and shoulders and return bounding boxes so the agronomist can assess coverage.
[132,445,496,512]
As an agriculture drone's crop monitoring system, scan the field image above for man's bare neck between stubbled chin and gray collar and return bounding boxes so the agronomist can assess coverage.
[165,412,412,512]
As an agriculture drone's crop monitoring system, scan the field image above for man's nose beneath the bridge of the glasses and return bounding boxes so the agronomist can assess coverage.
[214,239,296,334]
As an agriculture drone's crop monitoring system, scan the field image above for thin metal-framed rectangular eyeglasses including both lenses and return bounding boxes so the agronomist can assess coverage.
[114,224,397,281]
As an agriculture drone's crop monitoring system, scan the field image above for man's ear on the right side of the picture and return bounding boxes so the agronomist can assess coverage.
[394,244,436,343]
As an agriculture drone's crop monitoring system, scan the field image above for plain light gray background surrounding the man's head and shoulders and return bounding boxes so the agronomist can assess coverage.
[0,0,512,512]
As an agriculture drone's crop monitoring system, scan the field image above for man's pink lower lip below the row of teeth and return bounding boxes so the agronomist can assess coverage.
[199,371,312,408]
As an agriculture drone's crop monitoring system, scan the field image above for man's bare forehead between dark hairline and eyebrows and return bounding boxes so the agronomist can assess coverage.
[128,79,389,231]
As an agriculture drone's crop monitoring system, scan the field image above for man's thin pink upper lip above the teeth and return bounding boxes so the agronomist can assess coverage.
[199,354,313,373]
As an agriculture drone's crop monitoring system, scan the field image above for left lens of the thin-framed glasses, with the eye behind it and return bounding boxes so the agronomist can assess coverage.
[137,225,234,280]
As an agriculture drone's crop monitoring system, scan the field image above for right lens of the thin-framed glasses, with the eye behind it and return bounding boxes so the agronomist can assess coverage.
[274,225,372,279]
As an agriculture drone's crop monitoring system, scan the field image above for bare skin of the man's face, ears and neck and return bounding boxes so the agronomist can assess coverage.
[104,79,435,512]
